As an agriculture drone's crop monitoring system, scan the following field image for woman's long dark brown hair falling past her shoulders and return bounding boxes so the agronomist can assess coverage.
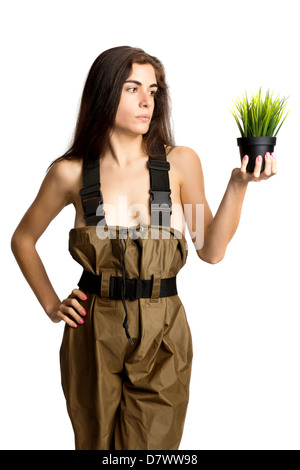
[47,46,175,171]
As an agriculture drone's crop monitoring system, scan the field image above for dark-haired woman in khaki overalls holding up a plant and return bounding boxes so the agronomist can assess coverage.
[12,46,277,450]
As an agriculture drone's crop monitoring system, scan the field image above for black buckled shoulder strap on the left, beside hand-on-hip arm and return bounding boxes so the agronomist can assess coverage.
[79,158,105,225]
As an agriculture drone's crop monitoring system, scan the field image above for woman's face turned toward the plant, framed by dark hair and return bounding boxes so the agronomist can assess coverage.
[114,64,158,135]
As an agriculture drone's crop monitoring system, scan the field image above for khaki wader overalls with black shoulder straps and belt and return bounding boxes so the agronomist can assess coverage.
[60,145,193,450]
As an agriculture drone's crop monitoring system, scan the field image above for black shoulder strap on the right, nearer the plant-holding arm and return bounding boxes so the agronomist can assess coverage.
[148,144,172,227]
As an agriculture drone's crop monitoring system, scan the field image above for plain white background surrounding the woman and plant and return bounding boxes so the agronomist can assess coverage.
[0,0,300,450]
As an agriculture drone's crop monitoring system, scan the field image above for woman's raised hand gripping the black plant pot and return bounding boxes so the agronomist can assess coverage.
[231,152,277,183]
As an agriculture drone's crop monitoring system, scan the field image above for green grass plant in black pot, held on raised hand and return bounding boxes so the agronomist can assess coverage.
[230,87,289,173]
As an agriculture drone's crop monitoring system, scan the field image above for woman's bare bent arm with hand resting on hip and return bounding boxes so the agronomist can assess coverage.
[11,160,84,327]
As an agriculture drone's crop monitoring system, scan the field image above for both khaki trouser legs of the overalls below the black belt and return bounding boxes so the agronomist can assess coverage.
[61,296,193,450]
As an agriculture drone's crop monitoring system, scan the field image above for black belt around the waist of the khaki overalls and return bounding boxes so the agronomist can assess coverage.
[78,269,177,300]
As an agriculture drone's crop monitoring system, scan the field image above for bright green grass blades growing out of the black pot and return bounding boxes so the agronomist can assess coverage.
[230,87,289,137]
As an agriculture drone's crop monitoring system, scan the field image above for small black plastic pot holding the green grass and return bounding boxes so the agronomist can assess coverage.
[237,136,276,173]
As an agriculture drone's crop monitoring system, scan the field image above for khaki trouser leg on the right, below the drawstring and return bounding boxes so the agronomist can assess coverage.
[115,299,193,450]
